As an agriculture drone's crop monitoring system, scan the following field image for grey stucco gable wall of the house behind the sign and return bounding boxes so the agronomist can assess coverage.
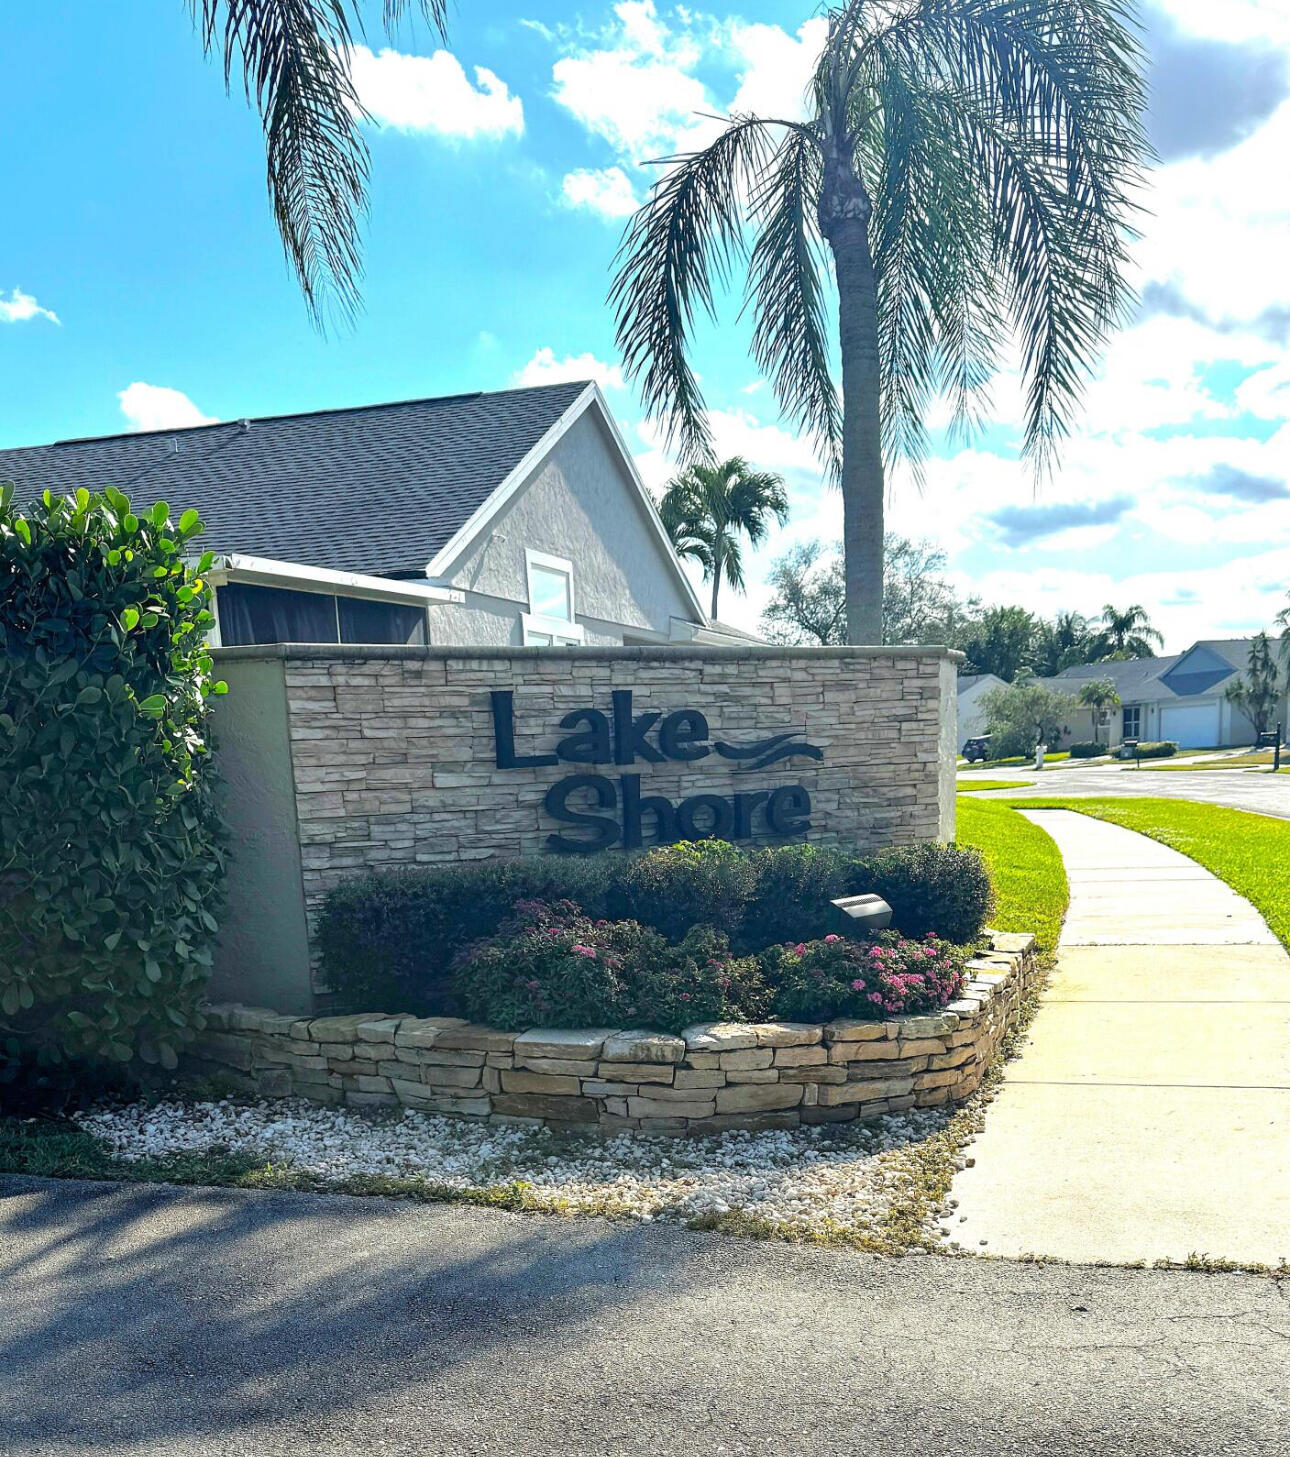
[430,411,694,645]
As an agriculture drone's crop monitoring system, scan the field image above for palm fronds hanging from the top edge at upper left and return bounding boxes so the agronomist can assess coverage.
[187,0,447,321]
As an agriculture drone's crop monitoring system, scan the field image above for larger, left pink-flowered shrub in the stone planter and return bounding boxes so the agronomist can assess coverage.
[453,900,768,1032]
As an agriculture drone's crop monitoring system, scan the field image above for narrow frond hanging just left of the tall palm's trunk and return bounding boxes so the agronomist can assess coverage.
[748,130,843,472]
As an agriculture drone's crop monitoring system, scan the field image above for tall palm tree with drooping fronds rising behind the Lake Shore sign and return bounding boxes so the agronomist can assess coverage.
[611,0,1150,643]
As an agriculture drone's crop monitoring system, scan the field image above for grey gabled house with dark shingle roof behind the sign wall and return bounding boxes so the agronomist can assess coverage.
[0,383,746,647]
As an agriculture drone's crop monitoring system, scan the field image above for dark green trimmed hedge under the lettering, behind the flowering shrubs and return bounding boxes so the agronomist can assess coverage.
[319,841,993,1016]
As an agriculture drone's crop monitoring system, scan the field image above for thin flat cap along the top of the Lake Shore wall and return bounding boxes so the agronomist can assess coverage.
[213,643,965,663]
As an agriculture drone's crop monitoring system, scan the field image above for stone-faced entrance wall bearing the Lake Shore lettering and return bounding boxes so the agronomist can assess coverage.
[217,645,955,1011]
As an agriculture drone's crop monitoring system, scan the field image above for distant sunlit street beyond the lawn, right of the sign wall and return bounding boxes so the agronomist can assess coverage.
[959,765,1290,819]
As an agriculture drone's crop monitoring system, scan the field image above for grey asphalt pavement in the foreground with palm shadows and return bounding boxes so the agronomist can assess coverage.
[0,1177,1290,1457]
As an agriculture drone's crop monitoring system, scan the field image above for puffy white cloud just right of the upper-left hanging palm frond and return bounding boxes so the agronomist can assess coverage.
[351,45,525,140]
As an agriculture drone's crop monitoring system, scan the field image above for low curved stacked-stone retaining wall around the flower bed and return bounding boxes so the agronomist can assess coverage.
[194,932,1035,1134]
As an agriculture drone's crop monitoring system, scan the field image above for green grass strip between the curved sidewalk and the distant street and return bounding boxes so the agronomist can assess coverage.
[1008,798,1290,947]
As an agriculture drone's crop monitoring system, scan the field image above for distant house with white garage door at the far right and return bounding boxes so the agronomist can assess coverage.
[1044,638,1286,749]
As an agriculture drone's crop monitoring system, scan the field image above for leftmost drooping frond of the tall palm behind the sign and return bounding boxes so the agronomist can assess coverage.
[609,117,770,459]
